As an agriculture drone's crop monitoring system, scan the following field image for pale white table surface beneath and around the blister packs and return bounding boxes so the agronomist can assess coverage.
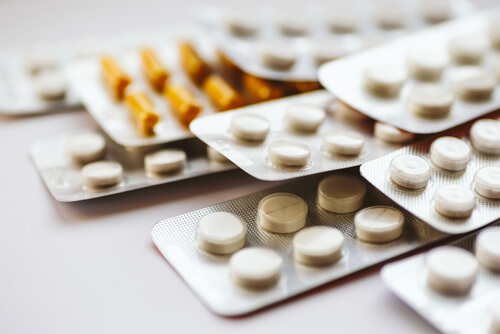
[0,0,488,334]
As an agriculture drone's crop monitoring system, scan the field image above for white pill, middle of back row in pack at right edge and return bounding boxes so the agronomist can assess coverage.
[430,136,471,171]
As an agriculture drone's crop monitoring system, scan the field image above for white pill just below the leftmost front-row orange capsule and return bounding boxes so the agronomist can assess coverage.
[144,149,187,174]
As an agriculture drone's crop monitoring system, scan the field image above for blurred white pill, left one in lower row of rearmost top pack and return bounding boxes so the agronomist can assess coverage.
[257,40,297,71]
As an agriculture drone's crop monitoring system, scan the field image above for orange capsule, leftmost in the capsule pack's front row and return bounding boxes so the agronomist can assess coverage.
[125,91,160,136]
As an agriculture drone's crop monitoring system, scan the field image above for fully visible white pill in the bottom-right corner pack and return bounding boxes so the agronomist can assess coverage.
[426,246,478,295]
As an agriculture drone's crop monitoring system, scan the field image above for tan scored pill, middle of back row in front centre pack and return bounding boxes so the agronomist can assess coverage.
[257,193,307,233]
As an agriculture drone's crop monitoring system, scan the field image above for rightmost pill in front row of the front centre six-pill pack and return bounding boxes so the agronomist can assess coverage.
[354,205,405,243]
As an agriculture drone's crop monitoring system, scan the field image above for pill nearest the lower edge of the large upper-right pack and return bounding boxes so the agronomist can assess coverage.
[408,84,454,118]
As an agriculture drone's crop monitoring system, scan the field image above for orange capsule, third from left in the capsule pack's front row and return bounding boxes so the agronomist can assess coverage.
[203,74,244,111]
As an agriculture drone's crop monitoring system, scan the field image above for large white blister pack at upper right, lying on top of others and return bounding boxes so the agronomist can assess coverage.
[319,9,500,134]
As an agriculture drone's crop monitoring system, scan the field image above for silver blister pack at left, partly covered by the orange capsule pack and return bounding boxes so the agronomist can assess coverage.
[30,129,236,202]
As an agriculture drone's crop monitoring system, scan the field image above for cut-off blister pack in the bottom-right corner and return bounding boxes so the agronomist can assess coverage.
[381,223,500,334]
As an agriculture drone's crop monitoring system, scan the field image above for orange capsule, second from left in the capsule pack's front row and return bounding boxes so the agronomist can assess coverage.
[164,85,202,126]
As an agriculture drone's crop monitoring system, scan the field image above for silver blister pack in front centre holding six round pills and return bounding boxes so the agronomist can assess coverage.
[152,168,447,316]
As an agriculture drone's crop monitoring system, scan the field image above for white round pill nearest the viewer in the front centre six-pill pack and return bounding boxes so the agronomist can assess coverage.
[229,247,283,289]
